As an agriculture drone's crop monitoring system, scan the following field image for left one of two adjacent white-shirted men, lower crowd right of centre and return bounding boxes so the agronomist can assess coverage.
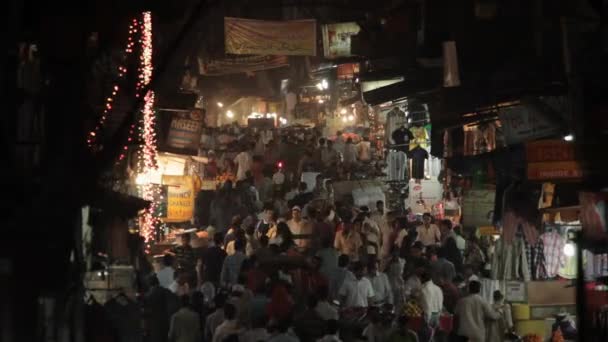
[338,262,374,308]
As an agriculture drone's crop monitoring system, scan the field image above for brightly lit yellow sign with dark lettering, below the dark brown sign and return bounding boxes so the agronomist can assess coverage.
[163,175,201,222]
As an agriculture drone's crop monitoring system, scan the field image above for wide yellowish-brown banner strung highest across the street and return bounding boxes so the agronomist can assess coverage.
[224,17,317,56]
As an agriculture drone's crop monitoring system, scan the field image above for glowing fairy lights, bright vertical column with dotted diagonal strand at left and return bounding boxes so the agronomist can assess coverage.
[87,12,161,246]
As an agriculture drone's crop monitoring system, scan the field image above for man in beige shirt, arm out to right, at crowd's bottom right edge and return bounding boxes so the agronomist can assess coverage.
[454,281,500,342]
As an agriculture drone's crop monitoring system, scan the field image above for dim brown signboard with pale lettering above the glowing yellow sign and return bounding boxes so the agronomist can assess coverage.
[167,110,204,151]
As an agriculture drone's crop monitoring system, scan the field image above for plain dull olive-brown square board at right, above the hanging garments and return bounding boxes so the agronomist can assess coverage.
[462,190,496,227]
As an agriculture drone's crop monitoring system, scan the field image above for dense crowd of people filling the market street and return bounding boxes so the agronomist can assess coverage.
[137,128,513,342]
